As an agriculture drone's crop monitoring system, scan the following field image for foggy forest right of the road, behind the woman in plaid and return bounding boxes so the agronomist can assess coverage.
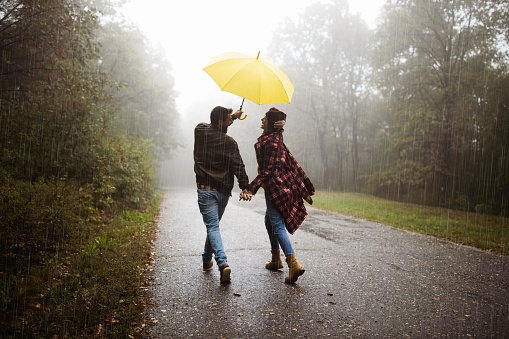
[262,0,509,216]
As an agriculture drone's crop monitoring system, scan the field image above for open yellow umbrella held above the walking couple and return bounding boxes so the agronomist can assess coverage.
[203,52,294,119]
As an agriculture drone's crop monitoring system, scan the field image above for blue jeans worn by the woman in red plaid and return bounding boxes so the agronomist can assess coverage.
[265,192,295,256]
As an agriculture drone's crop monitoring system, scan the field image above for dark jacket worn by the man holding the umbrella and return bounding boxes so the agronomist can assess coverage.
[194,123,249,196]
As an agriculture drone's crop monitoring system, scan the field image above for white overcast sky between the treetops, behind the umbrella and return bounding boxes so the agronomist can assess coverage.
[125,0,384,115]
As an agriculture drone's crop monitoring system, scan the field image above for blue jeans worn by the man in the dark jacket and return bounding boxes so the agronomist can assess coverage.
[198,189,230,267]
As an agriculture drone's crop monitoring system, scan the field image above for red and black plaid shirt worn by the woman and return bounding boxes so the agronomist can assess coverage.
[247,130,315,234]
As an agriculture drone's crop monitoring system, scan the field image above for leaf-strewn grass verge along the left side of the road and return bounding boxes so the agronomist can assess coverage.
[0,193,161,338]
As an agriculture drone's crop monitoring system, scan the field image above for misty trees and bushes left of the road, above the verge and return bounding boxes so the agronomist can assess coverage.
[0,0,178,241]
